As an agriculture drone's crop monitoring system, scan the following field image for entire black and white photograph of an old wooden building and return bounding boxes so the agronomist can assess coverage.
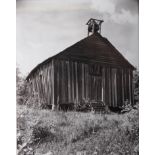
[16,0,139,155]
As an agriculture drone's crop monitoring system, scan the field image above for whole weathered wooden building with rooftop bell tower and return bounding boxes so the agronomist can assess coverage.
[26,18,135,109]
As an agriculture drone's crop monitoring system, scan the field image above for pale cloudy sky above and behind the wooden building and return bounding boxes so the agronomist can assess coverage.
[16,0,139,75]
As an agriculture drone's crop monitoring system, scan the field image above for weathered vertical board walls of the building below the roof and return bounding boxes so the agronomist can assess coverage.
[29,59,133,107]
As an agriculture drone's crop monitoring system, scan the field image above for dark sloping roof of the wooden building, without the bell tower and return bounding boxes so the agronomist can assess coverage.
[27,33,135,79]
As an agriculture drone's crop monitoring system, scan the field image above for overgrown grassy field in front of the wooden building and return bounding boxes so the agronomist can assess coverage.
[17,106,139,155]
